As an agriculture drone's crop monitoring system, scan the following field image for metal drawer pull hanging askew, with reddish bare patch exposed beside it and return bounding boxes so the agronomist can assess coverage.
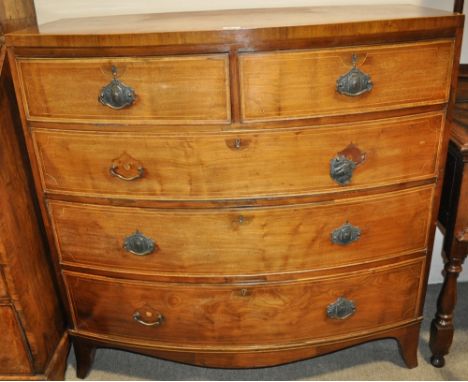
[330,143,366,185]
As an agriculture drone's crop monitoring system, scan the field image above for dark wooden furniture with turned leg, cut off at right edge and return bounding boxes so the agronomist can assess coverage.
[430,84,468,367]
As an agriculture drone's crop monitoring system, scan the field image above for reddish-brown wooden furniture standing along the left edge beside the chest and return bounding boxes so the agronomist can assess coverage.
[0,0,69,380]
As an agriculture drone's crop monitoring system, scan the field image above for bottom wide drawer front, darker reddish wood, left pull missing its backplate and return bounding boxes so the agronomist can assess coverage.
[66,260,423,346]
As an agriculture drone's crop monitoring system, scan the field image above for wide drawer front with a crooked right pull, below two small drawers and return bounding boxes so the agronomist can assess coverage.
[33,113,444,200]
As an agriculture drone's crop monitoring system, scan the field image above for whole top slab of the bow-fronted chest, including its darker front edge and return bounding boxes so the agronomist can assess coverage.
[7,4,463,48]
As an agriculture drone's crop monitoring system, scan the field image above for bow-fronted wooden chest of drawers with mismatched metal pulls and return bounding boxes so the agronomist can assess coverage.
[7,6,463,377]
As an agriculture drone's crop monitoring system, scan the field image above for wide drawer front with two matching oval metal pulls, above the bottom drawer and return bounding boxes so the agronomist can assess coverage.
[49,186,433,275]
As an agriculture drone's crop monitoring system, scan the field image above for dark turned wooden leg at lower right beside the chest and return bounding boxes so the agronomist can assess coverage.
[429,239,467,367]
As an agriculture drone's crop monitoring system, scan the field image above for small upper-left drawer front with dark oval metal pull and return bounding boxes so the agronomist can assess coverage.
[17,54,230,123]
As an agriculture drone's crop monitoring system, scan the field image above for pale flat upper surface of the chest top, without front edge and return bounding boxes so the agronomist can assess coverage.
[30,5,458,34]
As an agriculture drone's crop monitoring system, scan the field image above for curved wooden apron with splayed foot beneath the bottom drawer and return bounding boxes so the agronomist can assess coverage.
[72,317,422,368]
